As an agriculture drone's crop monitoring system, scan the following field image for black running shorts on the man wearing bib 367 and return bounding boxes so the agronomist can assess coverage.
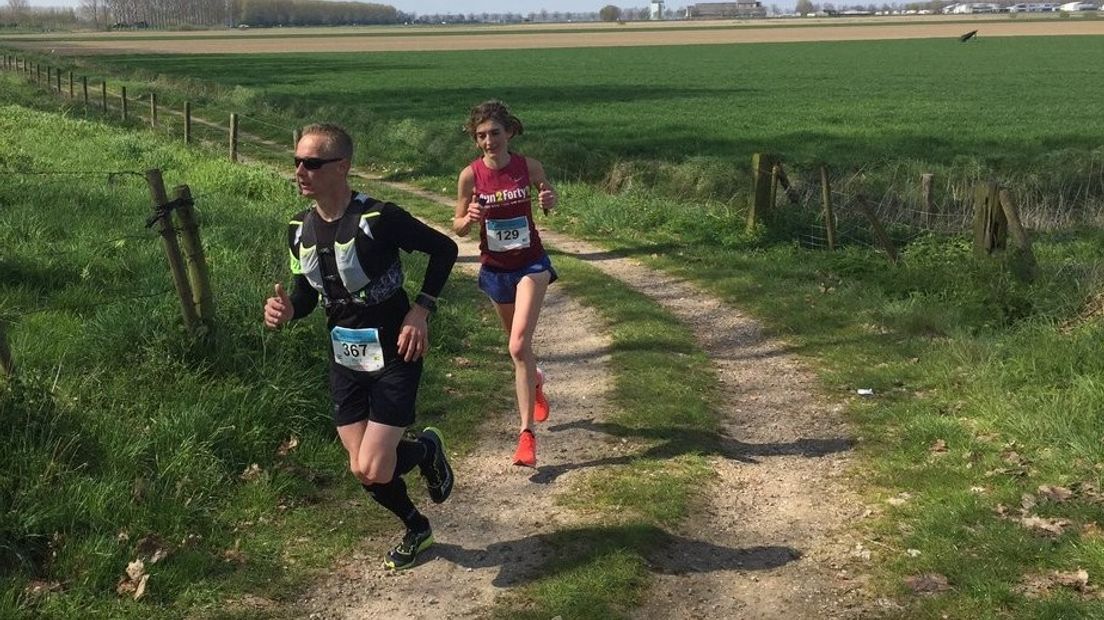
[330,360,422,428]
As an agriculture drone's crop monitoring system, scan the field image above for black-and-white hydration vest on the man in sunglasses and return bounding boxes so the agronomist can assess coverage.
[288,193,403,308]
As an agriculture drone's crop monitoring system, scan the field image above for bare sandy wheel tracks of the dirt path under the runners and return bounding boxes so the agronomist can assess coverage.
[308,179,873,620]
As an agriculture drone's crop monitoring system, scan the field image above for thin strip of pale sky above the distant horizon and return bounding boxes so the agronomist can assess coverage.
[21,0,693,15]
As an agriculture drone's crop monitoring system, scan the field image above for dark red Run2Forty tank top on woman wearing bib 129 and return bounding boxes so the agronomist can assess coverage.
[471,153,544,271]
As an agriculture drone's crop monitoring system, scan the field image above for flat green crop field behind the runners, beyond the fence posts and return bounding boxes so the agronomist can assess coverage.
[83,36,1104,179]
